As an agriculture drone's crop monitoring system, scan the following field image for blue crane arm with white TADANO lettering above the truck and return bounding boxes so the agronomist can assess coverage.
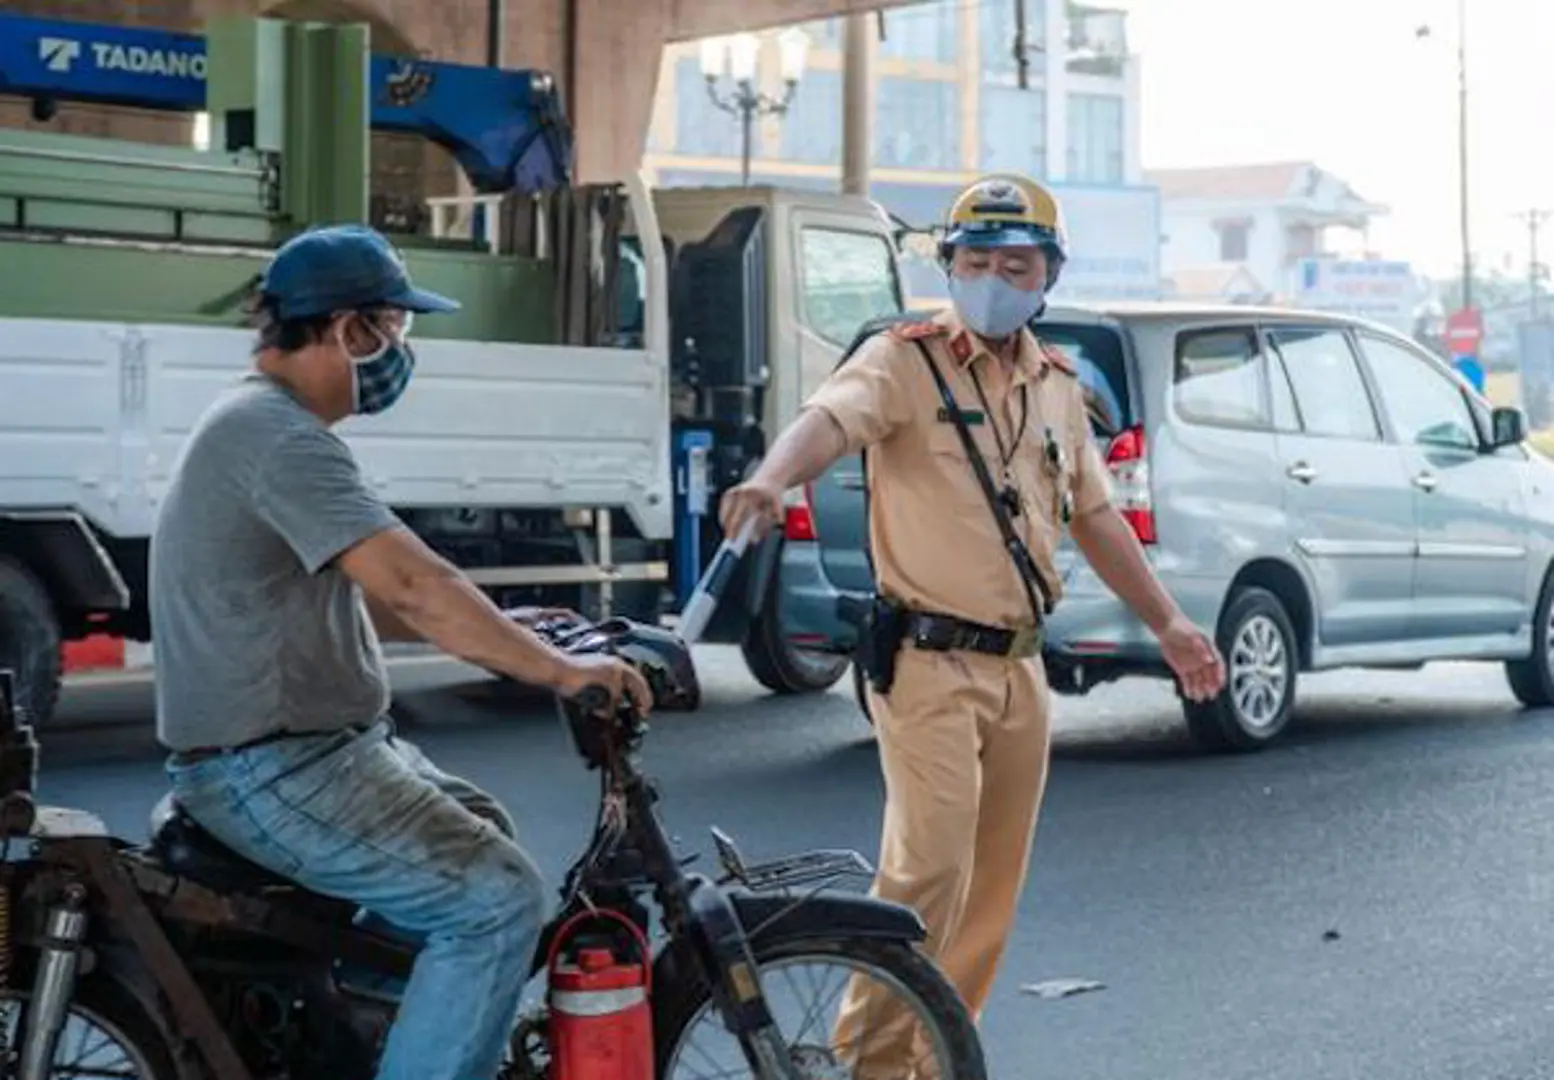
[0,14,572,193]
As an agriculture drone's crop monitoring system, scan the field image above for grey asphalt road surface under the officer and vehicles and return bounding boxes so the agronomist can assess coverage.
[42,650,1554,1080]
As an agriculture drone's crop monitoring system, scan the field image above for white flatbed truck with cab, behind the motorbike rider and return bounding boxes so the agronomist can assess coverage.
[0,172,904,723]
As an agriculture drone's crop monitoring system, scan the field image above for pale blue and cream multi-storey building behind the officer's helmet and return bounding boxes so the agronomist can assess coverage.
[643,0,1159,304]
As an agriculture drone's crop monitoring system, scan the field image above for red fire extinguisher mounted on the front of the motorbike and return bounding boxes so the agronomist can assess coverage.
[545,911,653,1080]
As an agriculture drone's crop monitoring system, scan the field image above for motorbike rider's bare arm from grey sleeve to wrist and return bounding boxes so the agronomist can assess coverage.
[339,527,570,687]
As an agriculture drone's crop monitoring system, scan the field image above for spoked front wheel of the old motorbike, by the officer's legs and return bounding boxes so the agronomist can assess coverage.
[653,937,987,1080]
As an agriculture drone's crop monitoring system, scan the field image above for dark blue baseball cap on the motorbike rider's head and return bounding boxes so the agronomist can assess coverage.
[260,225,462,319]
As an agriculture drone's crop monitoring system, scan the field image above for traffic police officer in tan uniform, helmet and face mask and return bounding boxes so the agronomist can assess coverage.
[720,176,1225,1077]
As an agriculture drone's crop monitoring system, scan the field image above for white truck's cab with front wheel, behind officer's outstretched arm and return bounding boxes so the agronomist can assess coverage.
[628,186,906,693]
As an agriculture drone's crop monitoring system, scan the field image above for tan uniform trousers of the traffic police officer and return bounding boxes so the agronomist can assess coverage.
[834,643,1051,1080]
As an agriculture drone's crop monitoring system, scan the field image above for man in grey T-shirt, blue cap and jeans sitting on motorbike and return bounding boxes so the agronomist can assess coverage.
[149,225,651,1080]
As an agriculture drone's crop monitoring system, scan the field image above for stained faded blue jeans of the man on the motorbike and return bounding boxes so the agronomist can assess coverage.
[168,721,544,1080]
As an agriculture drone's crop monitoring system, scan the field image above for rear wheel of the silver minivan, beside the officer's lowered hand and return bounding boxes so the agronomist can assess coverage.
[1183,587,1299,751]
